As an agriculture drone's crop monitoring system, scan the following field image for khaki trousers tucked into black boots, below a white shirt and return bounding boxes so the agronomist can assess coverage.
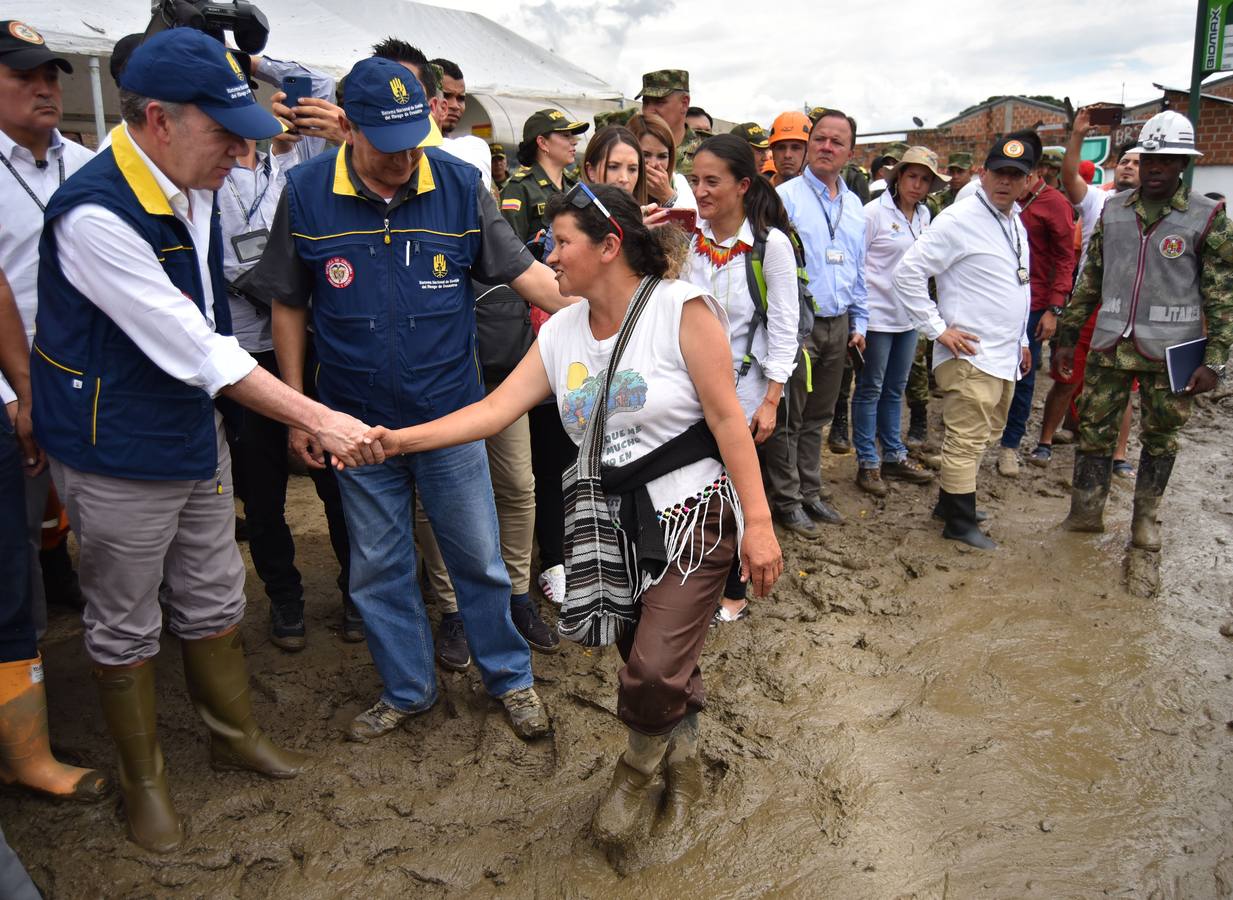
[933,359,1015,494]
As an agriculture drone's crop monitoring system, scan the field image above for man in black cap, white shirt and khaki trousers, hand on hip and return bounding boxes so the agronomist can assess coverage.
[894,132,1041,550]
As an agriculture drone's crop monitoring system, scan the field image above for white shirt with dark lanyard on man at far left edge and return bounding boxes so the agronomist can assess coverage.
[0,128,94,403]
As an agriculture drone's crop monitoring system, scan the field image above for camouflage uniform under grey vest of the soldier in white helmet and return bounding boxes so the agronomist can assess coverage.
[1058,179,1233,456]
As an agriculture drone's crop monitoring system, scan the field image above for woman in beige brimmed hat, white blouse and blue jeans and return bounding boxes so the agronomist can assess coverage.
[852,147,949,497]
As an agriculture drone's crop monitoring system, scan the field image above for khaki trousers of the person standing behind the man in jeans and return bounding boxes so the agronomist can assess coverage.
[416,415,535,613]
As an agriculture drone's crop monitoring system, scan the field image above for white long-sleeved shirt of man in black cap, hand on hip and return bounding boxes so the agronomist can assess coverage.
[893,189,1032,381]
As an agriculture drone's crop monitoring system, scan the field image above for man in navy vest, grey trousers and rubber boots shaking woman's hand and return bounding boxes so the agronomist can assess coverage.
[31,28,382,852]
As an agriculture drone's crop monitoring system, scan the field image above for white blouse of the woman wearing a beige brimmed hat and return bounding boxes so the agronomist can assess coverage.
[864,191,930,334]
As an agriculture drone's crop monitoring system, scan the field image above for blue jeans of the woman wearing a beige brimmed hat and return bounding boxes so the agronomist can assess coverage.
[852,332,917,468]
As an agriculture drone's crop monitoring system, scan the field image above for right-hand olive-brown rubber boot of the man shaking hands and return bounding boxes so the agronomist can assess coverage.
[180,626,308,778]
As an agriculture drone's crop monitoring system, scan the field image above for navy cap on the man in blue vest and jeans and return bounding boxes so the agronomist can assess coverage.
[343,57,441,153]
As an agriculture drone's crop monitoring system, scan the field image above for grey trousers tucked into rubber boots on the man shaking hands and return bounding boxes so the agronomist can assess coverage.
[52,416,244,666]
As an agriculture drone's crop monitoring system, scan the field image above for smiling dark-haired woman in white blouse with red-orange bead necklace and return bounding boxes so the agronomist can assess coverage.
[683,134,800,623]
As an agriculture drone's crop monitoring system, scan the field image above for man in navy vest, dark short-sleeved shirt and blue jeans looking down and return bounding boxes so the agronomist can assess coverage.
[249,58,577,741]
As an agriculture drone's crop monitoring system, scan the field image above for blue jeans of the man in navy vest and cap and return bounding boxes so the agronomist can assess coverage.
[338,441,531,713]
